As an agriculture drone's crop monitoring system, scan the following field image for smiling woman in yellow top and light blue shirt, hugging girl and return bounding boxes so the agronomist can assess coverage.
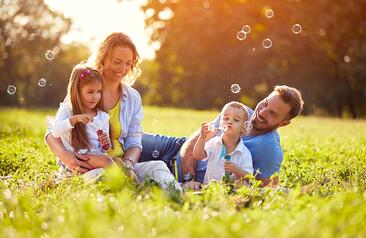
[46,32,180,192]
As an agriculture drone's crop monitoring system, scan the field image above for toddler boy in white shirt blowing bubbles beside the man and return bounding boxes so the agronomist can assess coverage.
[193,102,253,184]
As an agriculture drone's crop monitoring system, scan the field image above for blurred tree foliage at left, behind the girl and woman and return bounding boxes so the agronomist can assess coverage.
[0,0,88,106]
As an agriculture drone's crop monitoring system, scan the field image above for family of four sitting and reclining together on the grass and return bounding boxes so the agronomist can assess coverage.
[46,33,303,191]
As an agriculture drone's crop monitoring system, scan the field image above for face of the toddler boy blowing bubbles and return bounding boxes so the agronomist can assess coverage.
[220,107,248,135]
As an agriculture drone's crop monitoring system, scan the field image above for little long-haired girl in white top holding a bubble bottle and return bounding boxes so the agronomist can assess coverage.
[51,64,113,171]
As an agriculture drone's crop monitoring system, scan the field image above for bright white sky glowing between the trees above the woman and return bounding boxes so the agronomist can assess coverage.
[45,0,154,59]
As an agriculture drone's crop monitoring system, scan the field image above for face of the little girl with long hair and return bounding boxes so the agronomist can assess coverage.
[80,80,102,113]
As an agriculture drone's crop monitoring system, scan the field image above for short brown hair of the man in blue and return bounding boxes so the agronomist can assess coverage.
[272,85,304,120]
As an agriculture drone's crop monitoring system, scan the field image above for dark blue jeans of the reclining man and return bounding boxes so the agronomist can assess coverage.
[139,133,207,183]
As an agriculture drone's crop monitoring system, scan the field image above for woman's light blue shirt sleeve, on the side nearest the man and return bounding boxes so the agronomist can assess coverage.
[124,92,143,150]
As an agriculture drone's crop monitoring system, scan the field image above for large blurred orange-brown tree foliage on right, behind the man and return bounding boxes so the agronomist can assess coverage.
[139,0,366,117]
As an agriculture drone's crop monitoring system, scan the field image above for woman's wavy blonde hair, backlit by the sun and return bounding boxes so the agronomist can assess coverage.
[88,32,140,85]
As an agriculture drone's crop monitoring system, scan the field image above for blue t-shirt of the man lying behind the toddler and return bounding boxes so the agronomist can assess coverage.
[196,107,283,182]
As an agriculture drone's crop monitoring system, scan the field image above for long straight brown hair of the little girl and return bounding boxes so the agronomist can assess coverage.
[66,64,103,150]
